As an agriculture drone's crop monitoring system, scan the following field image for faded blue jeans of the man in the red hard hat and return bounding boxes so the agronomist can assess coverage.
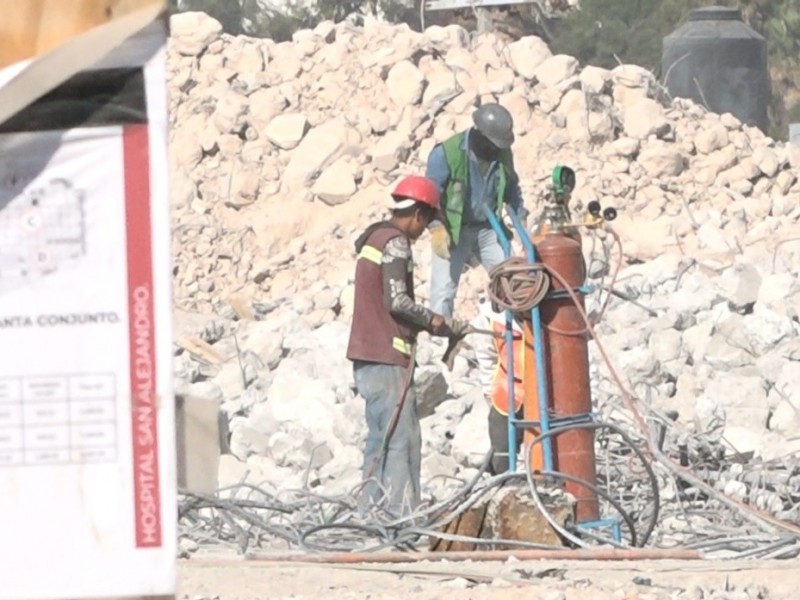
[353,361,422,517]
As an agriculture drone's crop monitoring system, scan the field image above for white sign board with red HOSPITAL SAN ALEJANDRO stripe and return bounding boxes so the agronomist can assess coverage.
[0,20,177,600]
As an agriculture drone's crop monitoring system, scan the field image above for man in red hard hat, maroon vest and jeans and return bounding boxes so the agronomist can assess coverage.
[347,176,468,516]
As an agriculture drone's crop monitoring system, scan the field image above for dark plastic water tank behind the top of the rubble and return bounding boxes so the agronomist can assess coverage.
[661,6,770,132]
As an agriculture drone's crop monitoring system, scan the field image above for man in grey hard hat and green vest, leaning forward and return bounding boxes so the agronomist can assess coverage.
[425,103,527,316]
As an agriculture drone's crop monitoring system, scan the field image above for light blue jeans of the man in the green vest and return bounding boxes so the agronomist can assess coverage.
[431,223,505,317]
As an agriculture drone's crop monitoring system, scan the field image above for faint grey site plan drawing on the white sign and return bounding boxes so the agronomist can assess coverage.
[0,175,86,293]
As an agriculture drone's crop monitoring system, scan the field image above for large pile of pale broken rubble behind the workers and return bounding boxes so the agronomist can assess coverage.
[169,13,800,518]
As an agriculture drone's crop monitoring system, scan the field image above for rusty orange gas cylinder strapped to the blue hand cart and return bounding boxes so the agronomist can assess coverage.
[526,233,599,522]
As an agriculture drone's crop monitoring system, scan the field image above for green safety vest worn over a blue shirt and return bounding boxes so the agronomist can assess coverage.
[442,131,514,245]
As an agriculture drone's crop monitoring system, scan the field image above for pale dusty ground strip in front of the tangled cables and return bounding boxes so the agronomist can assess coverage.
[178,556,800,600]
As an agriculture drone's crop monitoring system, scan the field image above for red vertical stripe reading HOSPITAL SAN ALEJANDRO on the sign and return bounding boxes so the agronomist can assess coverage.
[123,125,161,548]
